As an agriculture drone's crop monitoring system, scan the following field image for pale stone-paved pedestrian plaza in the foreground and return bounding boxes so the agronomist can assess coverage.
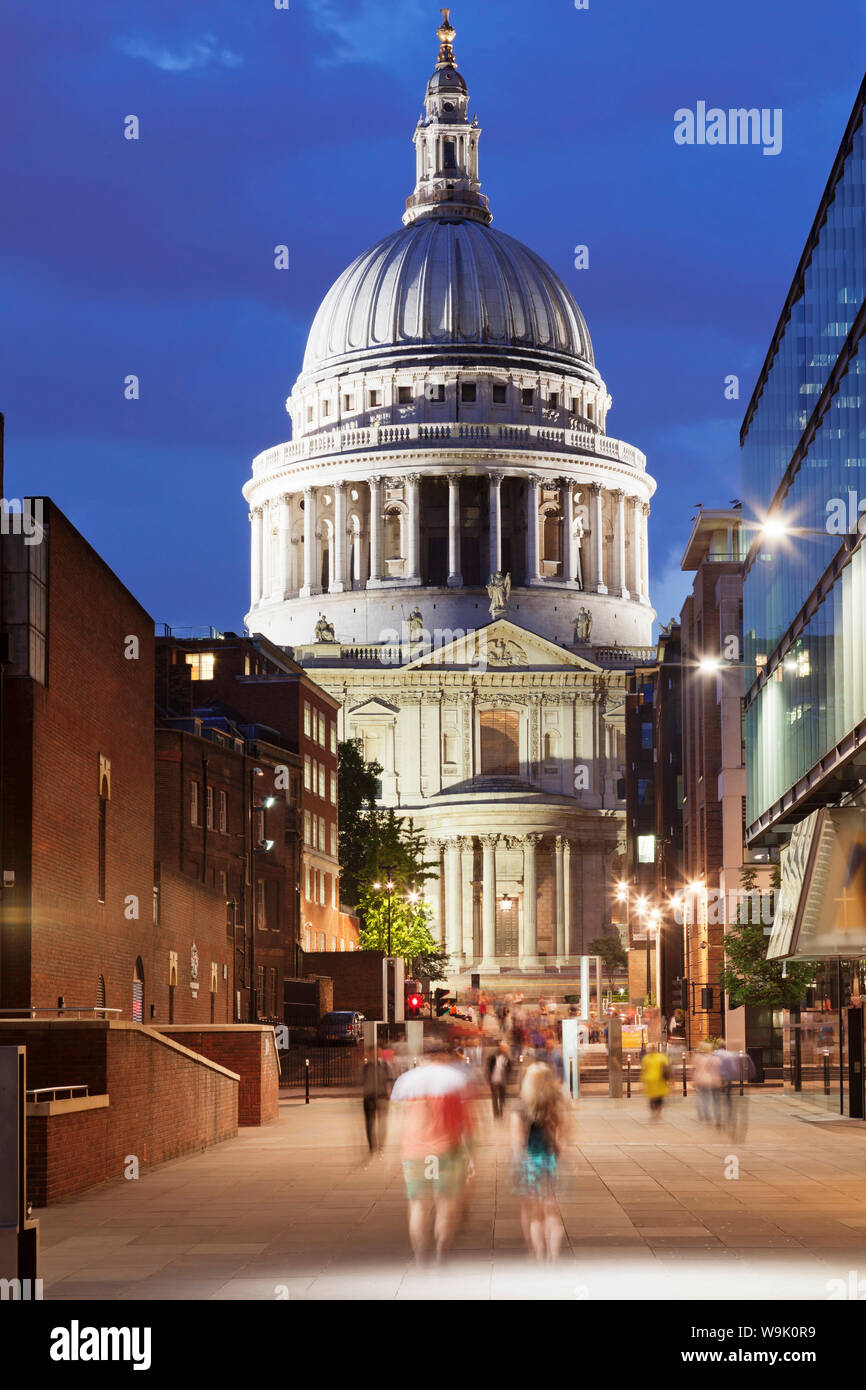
[35,1091,866,1300]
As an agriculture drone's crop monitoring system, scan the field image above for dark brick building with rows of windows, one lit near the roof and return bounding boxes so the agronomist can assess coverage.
[157,632,357,1017]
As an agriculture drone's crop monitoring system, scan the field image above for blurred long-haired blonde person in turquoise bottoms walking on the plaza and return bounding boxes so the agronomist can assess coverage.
[512,1062,564,1261]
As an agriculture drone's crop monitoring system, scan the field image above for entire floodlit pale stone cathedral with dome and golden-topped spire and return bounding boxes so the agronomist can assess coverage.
[243,11,655,992]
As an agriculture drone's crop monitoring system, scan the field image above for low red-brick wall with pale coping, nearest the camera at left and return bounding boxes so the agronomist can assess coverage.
[0,1020,238,1207]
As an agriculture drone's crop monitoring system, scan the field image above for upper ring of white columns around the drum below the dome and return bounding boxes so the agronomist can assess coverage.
[250,470,649,605]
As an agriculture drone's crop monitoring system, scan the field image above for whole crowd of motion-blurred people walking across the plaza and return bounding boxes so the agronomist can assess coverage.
[363,994,751,1262]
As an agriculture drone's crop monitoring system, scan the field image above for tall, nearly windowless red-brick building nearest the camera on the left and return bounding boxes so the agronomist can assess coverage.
[0,498,231,1022]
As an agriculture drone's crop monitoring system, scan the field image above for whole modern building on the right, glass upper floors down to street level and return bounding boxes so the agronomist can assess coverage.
[741,82,866,1116]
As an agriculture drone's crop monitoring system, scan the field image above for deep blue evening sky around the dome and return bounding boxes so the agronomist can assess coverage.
[0,0,866,628]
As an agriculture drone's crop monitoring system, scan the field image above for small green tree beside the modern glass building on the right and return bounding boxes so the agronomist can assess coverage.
[719,865,815,1009]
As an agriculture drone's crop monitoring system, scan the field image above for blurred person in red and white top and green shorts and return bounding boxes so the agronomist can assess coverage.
[391,1038,474,1262]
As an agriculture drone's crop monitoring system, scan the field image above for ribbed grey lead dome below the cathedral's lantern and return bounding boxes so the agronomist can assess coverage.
[303,217,594,375]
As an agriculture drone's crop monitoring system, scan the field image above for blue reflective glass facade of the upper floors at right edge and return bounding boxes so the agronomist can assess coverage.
[741,82,866,842]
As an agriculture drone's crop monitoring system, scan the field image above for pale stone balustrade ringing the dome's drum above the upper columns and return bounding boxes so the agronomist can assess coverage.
[253,421,646,475]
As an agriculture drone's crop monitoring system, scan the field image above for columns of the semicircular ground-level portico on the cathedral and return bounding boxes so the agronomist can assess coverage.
[427,833,581,970]
